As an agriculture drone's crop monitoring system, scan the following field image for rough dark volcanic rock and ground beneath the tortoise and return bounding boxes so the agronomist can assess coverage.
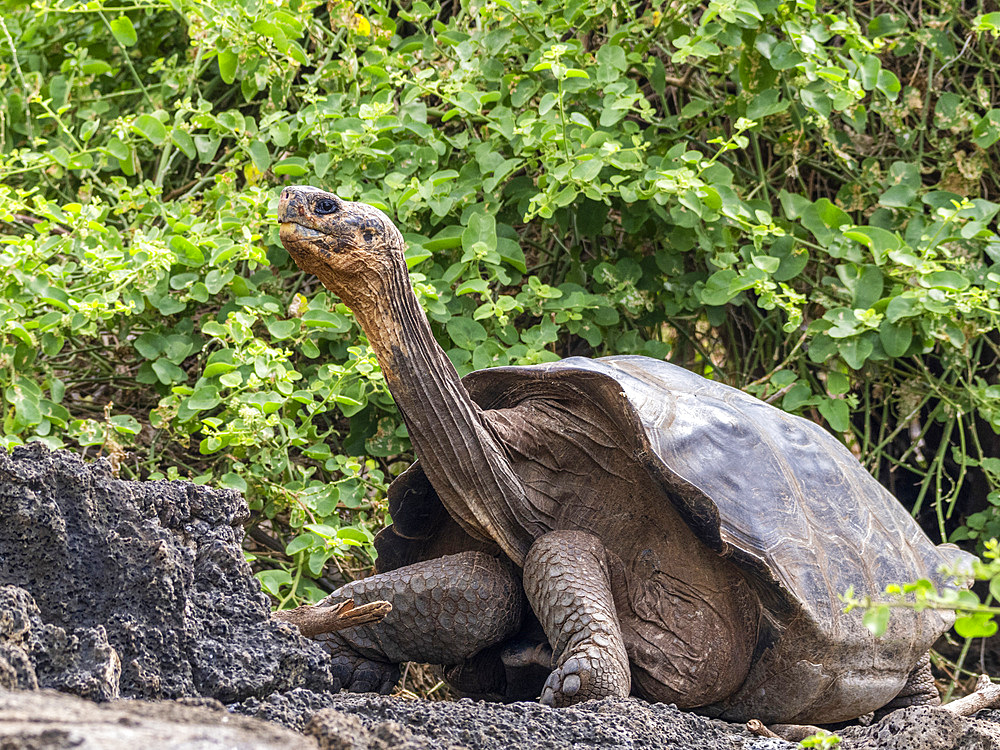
[0,446,1000,750]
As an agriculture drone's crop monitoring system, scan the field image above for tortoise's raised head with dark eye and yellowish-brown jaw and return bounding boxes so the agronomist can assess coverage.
[278,185,406,305]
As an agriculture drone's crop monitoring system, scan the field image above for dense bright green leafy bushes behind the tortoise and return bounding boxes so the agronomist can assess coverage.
[0,0,1000,602]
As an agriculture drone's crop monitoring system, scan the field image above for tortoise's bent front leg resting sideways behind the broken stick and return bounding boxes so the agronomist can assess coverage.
[306,552,524,693]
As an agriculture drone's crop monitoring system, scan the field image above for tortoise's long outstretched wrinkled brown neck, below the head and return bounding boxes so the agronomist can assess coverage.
[336,258,532,565]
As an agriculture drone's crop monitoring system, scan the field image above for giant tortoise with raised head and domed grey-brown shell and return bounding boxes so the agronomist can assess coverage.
[278,187,964,722]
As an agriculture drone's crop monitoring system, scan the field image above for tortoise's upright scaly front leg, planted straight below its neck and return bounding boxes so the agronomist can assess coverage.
[524,531,631,706]
